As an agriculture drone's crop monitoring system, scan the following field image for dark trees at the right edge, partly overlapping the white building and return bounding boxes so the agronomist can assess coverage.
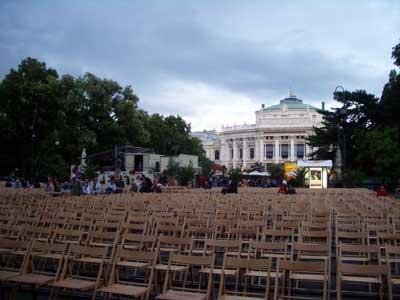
[309,39,400,187]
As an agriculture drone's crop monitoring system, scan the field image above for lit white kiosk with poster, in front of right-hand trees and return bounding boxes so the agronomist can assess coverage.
[297,160,332,189]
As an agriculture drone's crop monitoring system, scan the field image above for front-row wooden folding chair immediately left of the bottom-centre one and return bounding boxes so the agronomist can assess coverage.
[99,246,158,300]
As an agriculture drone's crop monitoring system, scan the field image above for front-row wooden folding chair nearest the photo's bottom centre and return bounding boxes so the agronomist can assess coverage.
[156,253,215,300]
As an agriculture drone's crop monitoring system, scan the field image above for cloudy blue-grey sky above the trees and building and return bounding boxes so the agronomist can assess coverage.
[0,0,400,130]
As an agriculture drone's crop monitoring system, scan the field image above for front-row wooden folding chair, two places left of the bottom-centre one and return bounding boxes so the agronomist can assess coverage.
[51,245,108,300]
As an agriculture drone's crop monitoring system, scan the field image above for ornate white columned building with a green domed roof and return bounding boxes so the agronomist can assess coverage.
[193,94,322,169]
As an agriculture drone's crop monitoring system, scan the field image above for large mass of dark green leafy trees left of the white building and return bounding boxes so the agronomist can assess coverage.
[0,58,203,179]
